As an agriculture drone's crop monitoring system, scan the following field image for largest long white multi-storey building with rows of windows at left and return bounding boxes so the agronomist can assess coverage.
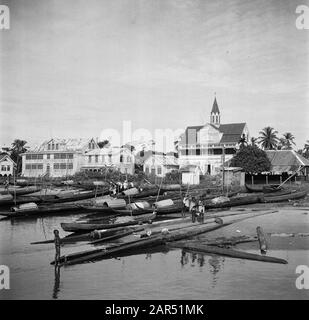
[22,138,98,177]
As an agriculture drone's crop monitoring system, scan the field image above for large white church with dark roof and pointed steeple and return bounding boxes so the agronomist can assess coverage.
[178,97,250,175]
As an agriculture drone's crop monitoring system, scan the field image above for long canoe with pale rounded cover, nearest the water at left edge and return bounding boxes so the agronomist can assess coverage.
[0,203,82,218]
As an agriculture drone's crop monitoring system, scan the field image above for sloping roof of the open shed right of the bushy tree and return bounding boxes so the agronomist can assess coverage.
[265,150,309,172]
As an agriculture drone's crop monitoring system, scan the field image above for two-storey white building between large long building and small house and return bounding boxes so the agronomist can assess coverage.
[81,147,135,174]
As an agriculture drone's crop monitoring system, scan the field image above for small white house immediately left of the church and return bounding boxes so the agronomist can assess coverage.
[143,152,179,177]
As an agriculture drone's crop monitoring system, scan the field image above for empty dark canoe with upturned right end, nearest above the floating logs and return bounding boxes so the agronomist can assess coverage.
[61,214,156,232]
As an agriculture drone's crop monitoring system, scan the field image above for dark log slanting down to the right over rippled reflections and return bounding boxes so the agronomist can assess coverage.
[169,242,288,264]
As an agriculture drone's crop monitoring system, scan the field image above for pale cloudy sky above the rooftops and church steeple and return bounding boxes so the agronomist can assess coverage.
[0,0,309,148]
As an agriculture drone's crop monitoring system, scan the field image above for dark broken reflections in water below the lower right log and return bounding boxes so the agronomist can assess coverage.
[180,249,225,287]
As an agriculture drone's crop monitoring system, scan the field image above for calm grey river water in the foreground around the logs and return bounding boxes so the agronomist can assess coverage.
[0,208,309,299]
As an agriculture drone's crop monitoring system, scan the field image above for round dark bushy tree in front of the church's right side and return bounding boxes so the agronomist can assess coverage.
[231,146,271,174]
